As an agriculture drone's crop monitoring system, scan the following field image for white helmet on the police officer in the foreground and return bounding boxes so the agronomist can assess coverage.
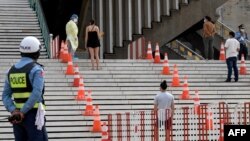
[20,36,41,53]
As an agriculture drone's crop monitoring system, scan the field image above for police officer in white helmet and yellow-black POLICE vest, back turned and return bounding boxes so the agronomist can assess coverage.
[2,36,48,141]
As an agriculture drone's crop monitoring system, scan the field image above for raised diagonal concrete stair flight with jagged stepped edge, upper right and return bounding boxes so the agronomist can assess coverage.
[143,0,227,46]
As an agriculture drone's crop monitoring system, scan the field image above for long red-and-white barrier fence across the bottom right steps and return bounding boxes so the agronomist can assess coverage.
[108,102,250,141]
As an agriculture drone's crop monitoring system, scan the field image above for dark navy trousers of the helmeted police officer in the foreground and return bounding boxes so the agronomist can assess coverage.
[13,109,48,141]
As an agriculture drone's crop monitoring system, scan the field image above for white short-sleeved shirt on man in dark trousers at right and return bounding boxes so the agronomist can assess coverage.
[225,38,240,58]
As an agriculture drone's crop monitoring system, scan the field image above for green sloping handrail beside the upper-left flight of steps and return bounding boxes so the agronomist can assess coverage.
[29,0,51,58]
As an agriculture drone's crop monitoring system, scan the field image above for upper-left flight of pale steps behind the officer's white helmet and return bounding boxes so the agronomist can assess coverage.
[0,0,48,59]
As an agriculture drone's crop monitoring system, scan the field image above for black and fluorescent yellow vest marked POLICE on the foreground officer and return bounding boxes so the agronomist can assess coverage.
[8,62,45,109]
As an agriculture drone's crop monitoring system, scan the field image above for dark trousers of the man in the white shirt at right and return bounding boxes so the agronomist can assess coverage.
[227,57,239,81]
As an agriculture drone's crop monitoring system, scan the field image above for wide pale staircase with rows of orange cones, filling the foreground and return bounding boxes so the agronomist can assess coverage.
[0,59,250,141]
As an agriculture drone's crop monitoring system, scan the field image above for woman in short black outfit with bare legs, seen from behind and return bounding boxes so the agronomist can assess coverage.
[85,20,101,70]
